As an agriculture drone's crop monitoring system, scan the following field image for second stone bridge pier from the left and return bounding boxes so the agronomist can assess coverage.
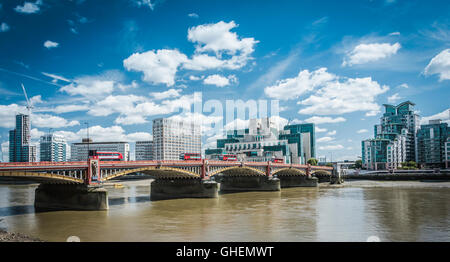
[150,178,219,200]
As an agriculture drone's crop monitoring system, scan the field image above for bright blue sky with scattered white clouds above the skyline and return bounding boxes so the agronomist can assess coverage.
[0,0,450,161]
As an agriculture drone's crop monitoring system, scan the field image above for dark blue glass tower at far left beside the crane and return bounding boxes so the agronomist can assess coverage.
[9,114,37,162]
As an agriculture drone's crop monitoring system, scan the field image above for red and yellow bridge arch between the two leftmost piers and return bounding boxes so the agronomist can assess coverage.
[102,166,200,181]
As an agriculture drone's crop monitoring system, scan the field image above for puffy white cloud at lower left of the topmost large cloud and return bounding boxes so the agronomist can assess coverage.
[123,49,187,86]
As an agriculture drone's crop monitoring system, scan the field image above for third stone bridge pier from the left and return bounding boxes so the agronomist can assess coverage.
[219,175,281,192]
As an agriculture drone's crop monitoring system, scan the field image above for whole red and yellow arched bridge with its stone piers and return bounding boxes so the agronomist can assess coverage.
[0,159,334,210]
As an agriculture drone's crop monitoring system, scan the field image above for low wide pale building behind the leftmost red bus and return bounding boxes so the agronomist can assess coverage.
[70,139,130,161]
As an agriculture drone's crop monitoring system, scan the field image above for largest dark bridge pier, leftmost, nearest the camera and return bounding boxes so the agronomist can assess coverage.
[34,184,108,211]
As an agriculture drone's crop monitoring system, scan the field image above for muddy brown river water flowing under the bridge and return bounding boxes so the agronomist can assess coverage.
[0,180,450,242]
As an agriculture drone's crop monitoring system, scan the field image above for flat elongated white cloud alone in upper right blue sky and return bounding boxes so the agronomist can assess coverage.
[342,43,401,66]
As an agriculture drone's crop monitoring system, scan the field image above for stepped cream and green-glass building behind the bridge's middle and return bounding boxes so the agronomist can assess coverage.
[205,118,315,164]
